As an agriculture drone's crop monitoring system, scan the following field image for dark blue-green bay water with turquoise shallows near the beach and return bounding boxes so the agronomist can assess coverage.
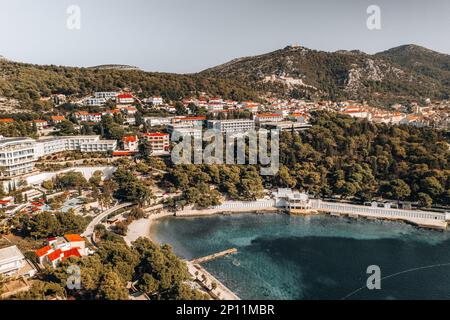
[155,214,450,300]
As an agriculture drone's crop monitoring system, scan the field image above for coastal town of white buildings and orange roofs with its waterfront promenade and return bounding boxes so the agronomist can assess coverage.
[0,88,450,299]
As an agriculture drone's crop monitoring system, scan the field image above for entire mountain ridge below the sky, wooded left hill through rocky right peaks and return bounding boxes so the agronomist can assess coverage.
[0,45,450,107]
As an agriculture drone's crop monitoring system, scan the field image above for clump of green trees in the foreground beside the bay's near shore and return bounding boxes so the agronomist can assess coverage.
[13,238,206,300]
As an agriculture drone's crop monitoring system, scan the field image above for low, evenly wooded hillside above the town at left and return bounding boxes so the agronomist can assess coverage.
[0,60,256,108]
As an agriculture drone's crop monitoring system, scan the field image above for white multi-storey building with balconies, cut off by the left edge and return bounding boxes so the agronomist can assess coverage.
[0,136,35,178]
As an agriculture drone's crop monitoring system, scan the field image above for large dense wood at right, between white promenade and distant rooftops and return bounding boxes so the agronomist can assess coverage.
[274,112,450,205]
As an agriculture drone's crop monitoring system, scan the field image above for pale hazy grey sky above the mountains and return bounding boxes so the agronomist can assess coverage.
[0,0,450,73]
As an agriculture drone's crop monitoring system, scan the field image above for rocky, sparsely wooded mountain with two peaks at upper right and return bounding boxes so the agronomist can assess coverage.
[200,45,450,101]
